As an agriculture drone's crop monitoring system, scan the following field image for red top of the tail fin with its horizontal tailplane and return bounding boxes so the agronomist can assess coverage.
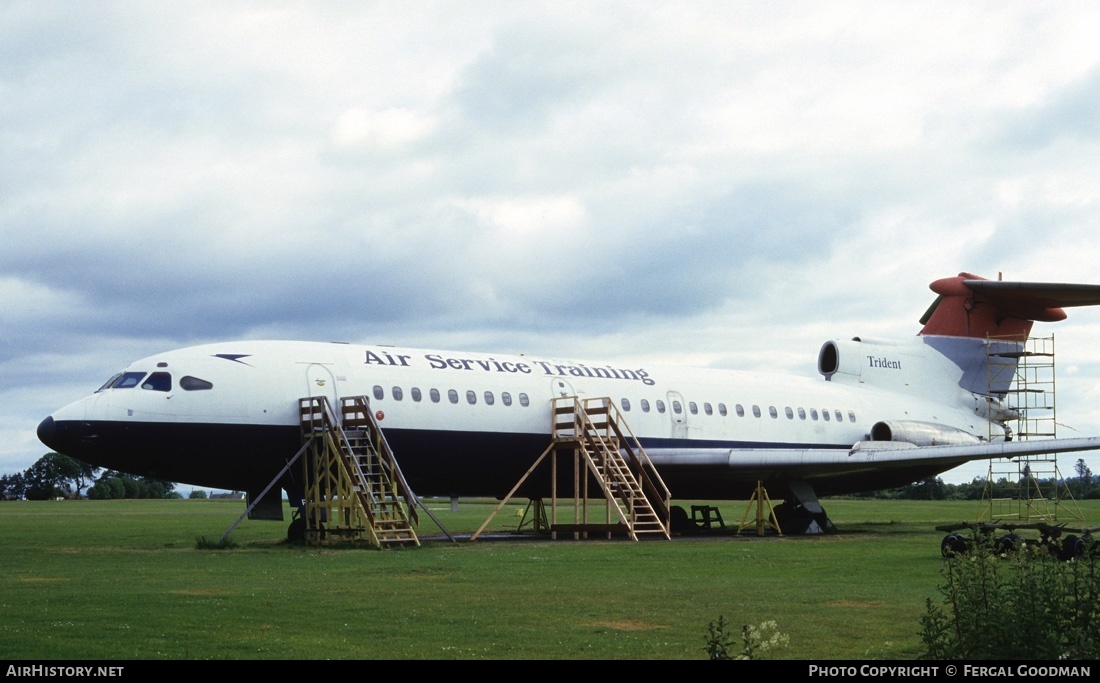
[920,273,1100,341]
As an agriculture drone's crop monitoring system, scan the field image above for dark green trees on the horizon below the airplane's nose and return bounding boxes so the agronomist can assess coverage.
[0,453,180,500]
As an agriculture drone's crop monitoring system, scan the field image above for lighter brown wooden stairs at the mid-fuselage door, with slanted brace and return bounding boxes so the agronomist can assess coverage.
[470,396,672,541]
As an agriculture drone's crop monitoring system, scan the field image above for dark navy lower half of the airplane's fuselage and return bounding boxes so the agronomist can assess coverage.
[36,421,963,508]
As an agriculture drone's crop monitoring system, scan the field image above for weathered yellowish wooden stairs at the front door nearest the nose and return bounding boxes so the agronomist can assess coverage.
[298,396,420,548]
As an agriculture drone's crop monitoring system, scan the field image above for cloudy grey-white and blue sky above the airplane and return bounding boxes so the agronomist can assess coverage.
[0,0,1100,482]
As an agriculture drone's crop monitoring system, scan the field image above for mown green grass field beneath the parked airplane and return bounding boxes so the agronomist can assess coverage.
[0,500,1100,660]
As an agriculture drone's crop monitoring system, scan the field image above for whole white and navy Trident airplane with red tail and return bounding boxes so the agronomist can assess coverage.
[37,273,1100,533]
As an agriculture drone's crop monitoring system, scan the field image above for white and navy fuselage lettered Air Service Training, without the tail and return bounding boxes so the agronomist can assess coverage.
[40,340,1003,498]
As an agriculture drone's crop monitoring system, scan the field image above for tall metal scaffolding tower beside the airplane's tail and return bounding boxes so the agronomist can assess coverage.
[979,335,1081,524]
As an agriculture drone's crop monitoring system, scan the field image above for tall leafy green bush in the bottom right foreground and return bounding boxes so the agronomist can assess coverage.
[920,537,1100,660]
